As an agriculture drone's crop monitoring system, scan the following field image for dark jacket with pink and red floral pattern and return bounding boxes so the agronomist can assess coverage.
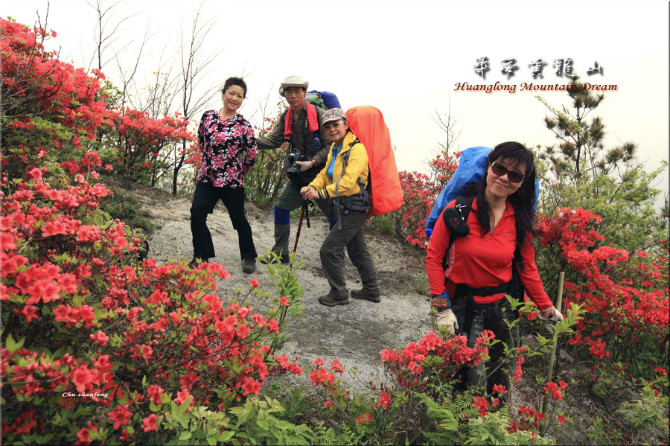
[198,110,258,189]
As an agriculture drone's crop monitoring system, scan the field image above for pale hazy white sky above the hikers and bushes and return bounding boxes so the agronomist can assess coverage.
[3,0,670,203]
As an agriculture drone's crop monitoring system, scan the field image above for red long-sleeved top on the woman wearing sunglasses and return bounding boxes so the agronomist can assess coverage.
[426,198,553,310]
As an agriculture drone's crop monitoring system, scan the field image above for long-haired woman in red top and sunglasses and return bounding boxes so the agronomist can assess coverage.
[426,142,562,393]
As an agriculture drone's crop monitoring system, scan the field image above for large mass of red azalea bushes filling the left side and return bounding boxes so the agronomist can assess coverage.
[0,19,302,444]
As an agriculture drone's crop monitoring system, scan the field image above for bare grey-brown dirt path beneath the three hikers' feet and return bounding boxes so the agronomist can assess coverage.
[133,188,431,390]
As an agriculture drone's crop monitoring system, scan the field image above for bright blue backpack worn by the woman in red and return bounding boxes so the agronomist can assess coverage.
[426,146,540,238]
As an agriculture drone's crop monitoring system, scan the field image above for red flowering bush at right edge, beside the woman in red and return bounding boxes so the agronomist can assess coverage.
[538,208,670,359]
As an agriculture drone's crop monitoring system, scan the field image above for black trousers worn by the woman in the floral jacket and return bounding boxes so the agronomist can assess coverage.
[191,182,258,260]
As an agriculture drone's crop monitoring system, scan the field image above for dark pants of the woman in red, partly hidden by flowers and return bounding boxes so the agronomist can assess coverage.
[451,296,517,394]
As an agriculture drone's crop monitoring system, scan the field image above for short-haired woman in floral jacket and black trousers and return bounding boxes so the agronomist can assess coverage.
[190,77,257,274]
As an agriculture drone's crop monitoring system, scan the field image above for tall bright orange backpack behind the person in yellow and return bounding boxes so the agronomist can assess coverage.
[347,105,403,217]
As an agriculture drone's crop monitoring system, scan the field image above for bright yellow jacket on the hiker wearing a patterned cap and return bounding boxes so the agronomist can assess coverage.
[309,132,369,199]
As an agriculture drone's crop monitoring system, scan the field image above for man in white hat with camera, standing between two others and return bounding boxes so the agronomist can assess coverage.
[256,76,330,263]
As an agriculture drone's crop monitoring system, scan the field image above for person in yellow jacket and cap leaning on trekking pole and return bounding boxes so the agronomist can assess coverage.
[300,108,381,307]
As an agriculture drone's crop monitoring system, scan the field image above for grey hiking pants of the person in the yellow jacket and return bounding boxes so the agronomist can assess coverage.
[319,213,380,299]
